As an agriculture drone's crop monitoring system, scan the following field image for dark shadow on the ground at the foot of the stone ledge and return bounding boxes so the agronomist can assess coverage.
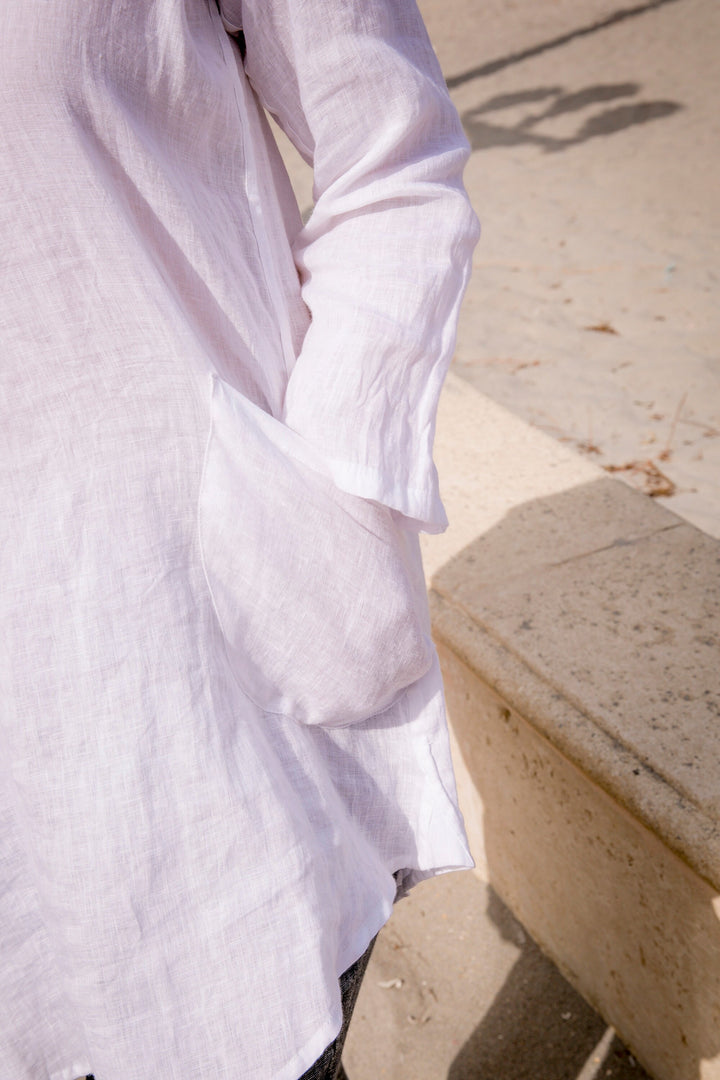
[447,889,650,1080]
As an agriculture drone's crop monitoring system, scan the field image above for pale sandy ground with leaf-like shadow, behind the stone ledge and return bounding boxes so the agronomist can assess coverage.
[433,0,720,536]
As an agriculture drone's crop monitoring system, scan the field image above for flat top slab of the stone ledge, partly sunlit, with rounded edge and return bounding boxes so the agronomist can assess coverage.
[425,381,720,889]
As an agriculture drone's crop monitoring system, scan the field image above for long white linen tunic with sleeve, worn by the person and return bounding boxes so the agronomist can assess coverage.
[0,0,477,1080]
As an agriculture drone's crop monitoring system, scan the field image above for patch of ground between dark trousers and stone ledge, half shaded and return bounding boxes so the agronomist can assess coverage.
[343,870,650,1080]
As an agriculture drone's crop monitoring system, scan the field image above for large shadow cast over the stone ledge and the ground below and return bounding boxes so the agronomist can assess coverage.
[431,478,720,1080]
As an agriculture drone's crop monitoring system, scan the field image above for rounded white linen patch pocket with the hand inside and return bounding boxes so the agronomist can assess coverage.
[199,377,433,726]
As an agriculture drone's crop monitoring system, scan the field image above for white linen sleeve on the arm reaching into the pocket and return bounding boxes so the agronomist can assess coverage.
[235,0,479,531]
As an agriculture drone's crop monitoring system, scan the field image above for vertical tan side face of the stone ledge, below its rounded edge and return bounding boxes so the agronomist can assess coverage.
[435,647,720,1080]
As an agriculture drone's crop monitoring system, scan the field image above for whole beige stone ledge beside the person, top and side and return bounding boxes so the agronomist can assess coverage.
[423,377,720,1080]
